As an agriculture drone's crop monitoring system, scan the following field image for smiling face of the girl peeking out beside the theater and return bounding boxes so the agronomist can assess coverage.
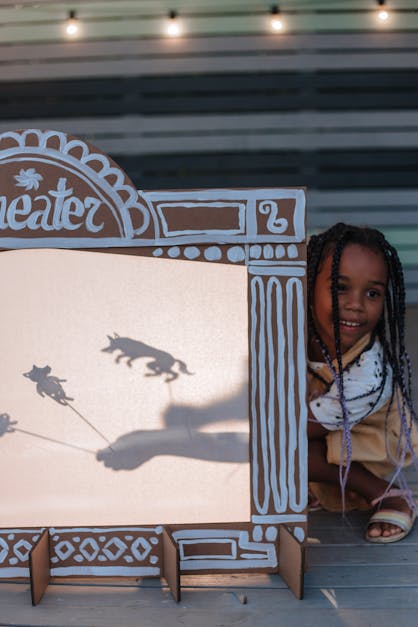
[311,244,387,359]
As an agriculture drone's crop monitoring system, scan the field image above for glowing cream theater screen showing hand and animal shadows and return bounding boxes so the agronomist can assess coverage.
[0,249,250,527]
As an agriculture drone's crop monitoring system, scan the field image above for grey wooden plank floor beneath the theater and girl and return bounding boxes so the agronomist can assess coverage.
[0,475,418,627]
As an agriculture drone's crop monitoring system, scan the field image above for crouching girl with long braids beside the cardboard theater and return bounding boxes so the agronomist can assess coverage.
[308,223,418,543]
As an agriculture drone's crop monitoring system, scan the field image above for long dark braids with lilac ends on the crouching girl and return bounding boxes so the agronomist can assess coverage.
[307,222,417,507]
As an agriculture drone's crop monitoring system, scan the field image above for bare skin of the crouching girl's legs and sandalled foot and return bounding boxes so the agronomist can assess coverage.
[308,432,411,537]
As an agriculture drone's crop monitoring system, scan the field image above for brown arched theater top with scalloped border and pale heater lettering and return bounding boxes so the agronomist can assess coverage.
[0,129,157,247]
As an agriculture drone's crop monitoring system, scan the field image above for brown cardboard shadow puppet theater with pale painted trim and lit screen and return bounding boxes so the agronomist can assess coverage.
[0,130,307,603]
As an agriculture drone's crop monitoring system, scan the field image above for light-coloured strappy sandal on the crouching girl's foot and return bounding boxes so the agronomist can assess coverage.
[365,488,417,544]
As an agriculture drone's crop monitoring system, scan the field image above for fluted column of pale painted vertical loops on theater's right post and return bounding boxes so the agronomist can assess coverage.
[250,267,307,523]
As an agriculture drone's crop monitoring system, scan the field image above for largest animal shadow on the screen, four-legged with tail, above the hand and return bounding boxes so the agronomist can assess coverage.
[102,333,193,383]
